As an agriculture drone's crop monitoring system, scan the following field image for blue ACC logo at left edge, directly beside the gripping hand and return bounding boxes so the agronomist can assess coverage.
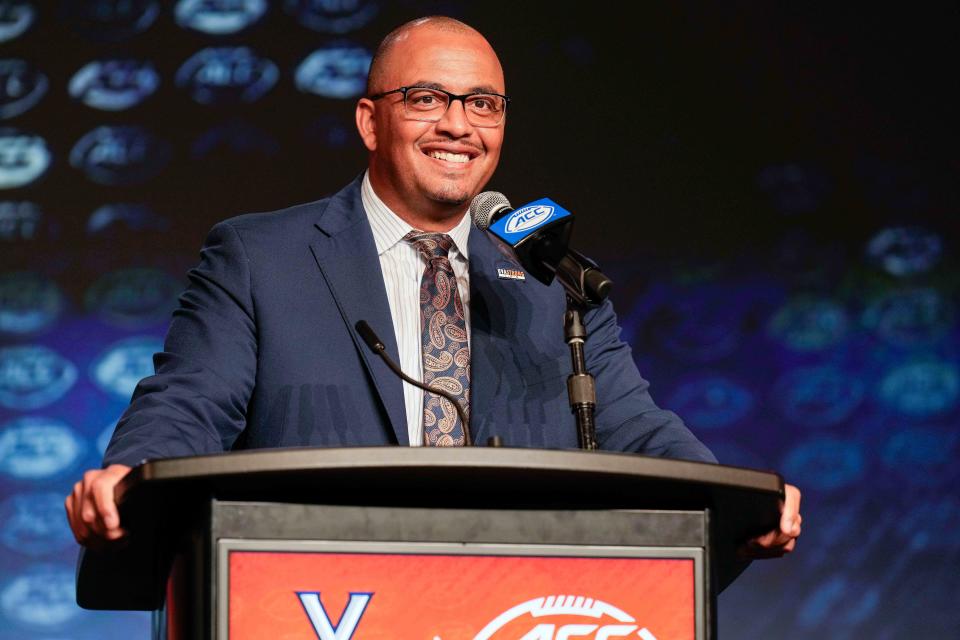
[0,493,73,556]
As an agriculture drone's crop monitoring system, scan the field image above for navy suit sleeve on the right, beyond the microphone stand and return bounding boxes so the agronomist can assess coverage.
[584,300,717,462]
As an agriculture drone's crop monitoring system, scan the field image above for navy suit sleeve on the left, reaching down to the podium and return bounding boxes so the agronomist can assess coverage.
[104,222,257,466]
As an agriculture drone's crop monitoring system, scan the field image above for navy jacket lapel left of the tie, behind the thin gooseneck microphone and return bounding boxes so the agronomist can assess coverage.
[310,178,410,445]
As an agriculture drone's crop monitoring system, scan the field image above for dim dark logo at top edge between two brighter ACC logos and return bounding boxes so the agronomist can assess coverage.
[62,0,160,41]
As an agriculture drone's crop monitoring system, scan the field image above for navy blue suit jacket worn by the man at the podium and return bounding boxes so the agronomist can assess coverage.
[104,179,714,465]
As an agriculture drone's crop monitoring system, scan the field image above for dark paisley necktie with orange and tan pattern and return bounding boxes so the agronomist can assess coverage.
[404,231,470,447]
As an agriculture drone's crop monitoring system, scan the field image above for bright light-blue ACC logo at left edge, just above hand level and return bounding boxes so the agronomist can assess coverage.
[0,416,84,480]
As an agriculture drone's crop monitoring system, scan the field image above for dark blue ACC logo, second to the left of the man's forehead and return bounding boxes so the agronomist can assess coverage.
[176,47,280,104]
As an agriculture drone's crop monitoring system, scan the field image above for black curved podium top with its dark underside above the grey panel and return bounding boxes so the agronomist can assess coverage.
[77,447,783,609]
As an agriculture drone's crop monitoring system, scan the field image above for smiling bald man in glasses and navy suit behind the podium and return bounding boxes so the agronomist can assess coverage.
[66,17,800,557]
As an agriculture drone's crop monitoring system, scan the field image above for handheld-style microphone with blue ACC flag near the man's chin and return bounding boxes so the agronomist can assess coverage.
[470,191,613,306]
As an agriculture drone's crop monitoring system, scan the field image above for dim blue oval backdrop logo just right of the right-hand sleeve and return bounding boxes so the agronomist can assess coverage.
[666,375,754,429]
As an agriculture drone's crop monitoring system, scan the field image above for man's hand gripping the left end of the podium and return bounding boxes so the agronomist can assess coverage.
[64,464,130,549]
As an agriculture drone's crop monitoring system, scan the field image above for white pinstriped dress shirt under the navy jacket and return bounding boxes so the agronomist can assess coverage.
[360,173,470,447]
